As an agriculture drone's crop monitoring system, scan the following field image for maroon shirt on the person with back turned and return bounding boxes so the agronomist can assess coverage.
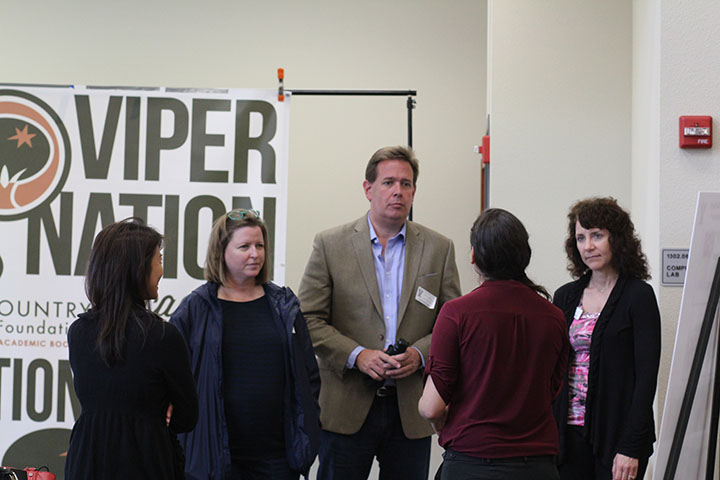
[425,280,569,458]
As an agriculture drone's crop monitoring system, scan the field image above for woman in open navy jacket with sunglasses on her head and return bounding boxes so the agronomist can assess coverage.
[170,209,320,480]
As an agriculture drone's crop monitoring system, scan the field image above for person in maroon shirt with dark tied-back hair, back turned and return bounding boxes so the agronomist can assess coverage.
[418,209,569,480]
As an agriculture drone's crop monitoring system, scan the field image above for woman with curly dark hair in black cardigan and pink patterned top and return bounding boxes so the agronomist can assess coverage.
[553,198,660,480]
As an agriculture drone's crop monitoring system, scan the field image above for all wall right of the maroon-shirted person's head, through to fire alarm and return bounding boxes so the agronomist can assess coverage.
[488,0,720,476]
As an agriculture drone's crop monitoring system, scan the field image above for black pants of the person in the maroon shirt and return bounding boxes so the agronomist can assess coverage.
[435,448,560,480]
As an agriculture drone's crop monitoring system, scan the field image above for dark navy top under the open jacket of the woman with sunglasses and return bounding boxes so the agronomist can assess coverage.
[221,295,285,461]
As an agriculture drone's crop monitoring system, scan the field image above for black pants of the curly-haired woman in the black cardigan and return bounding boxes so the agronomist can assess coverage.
[558,425,648,480]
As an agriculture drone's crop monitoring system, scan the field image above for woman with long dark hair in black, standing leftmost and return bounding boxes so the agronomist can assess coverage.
[65,218,198,480]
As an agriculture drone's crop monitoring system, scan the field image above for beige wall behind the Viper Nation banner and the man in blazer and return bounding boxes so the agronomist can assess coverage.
[0,0,487,478]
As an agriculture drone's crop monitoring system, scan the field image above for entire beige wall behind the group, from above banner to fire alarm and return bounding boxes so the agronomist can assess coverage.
[18,0,720,476]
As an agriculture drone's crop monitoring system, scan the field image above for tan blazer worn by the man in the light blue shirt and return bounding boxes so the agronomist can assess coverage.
[298,215,460,438]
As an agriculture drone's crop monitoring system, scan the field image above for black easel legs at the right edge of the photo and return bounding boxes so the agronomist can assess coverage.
[663,258,720,480]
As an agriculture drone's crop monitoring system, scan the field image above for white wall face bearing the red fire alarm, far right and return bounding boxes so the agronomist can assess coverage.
[652,0,720,464]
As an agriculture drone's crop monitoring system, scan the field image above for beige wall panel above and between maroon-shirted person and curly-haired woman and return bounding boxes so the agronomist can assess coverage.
[488,0,632,291]
